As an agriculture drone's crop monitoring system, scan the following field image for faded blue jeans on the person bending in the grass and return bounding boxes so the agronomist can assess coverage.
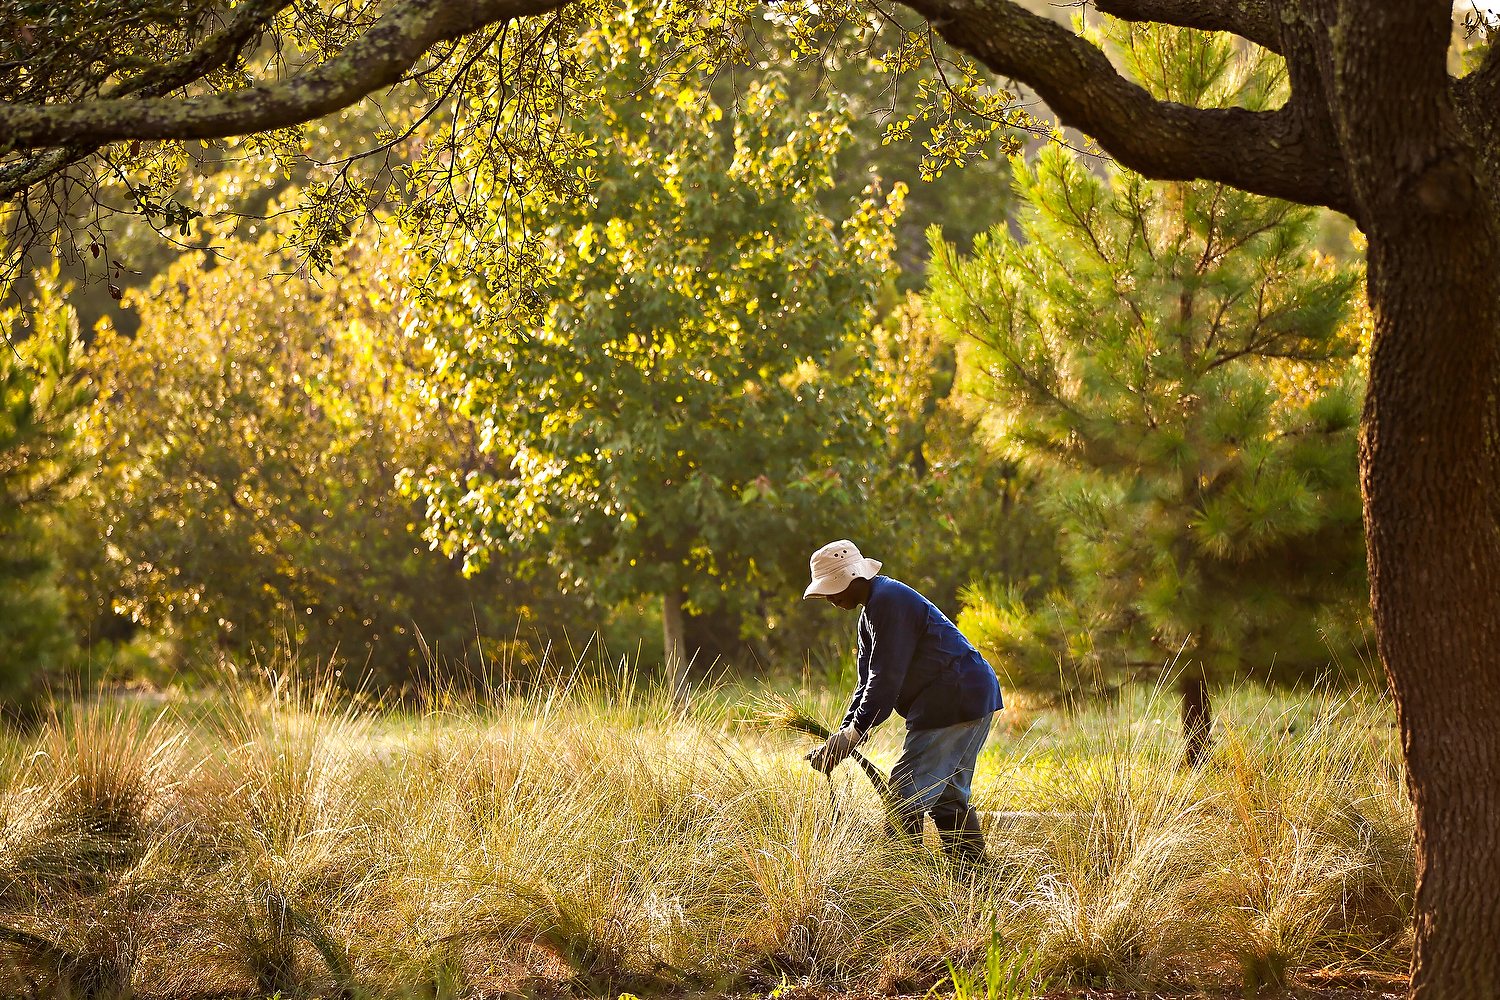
[891,712,995,837]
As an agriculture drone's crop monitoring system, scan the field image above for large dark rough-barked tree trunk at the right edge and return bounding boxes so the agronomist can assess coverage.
[1323,3,1500,1000]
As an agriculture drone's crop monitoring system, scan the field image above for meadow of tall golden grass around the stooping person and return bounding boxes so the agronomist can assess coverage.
[0,653,1413,997]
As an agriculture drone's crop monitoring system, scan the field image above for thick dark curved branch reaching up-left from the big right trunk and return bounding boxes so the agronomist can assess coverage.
[905,0,1353,213]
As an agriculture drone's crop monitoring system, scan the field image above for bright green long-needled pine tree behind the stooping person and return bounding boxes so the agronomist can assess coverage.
[930,25,1368,762]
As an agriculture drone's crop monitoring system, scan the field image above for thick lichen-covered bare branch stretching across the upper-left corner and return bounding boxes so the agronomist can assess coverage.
[0,0,566,150]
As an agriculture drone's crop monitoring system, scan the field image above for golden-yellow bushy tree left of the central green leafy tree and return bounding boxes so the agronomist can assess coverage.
[75,237,582,685]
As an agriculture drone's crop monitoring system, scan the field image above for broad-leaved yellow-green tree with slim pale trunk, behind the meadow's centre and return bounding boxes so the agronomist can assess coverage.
[420,68,900,690]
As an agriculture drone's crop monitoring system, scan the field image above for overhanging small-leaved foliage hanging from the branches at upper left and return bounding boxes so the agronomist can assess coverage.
[0,0,1043,310]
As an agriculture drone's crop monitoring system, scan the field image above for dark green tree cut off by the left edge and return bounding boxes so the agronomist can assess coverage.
[0,267,93,712]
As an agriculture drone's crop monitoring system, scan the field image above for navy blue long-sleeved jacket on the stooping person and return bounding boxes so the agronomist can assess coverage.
[843,576,1002,733]
